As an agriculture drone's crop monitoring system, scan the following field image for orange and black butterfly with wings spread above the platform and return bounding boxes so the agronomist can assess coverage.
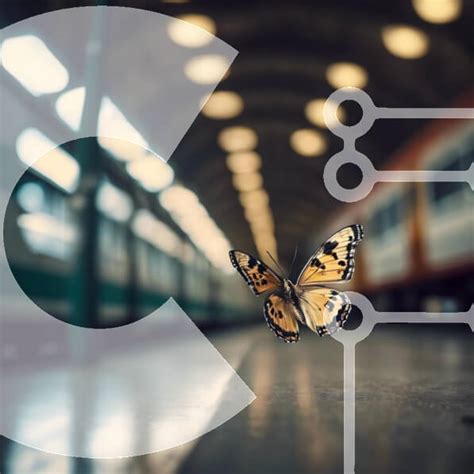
[229,225,364,342]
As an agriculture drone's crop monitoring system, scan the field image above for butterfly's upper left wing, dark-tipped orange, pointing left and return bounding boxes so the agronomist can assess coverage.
[229,250,282,296]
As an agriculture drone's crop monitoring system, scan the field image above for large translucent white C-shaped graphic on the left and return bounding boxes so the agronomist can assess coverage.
[0,7,255,458]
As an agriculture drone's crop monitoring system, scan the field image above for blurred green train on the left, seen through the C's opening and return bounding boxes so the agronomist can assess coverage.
[4,171,253,329]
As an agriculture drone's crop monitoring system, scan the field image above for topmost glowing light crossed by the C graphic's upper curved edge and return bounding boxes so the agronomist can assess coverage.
[168,14,216,48]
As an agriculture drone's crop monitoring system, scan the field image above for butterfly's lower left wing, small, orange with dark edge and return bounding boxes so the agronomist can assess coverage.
[263,293,300,342]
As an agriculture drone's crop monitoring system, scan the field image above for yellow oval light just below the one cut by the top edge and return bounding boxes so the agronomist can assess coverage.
[382,25,430,59]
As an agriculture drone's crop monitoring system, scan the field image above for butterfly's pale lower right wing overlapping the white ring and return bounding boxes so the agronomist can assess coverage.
[299,286,351,336]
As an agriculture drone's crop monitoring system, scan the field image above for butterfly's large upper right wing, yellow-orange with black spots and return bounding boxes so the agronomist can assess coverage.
[297,225,364,286]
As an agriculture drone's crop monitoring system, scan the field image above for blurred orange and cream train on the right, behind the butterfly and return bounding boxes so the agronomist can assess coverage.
[308,94,474,312]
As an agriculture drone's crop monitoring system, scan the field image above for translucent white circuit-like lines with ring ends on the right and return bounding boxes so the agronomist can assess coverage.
[324,87,474,474]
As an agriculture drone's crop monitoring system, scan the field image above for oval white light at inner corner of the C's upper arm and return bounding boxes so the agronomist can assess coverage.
[127,155,174,192]
